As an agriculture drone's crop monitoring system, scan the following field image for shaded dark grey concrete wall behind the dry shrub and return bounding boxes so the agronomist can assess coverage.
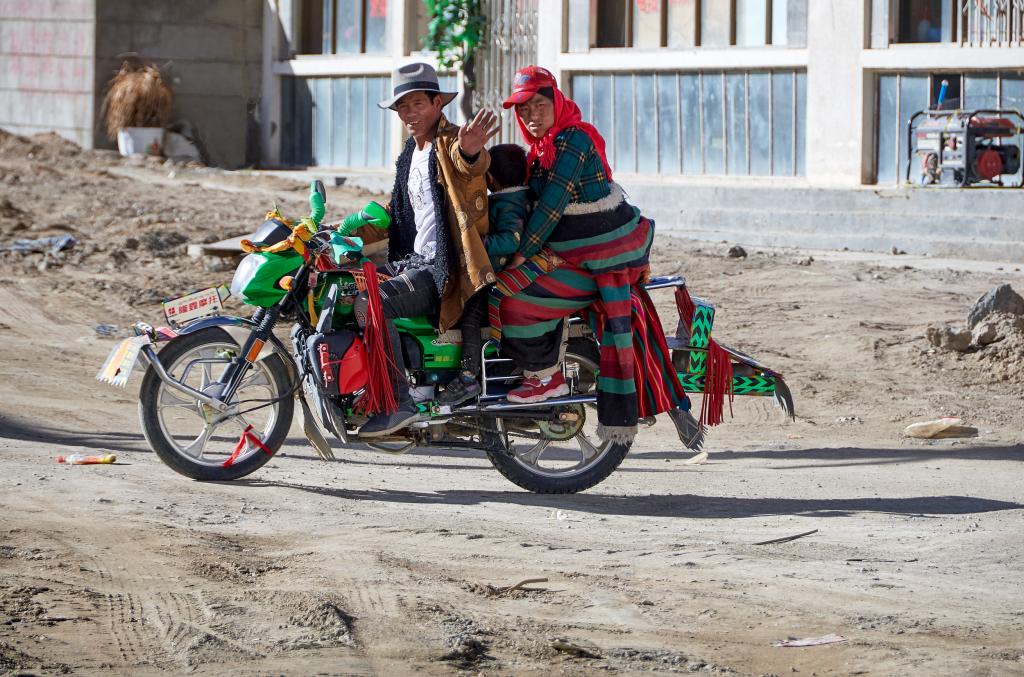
[95,0,263,168]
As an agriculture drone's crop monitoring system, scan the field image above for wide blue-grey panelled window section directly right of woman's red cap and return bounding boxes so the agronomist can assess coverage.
[569,70,807,176]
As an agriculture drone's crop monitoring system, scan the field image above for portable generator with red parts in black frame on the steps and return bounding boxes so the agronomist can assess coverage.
[906,109,1024,187]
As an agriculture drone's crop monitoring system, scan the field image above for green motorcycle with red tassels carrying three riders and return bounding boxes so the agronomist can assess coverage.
[97,181,793,494]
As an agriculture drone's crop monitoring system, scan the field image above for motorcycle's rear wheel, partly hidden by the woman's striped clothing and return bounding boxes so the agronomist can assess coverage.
[484,339,630,494]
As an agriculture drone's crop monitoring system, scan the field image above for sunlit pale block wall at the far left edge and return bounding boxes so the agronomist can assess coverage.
[0,0,96,147]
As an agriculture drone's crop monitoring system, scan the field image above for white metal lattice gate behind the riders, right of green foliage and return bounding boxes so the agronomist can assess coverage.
[473,0,538,143]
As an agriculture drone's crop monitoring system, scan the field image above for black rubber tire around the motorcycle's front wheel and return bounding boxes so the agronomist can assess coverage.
[138,327,295,481]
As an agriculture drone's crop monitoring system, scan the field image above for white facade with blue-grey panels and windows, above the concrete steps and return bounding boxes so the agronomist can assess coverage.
[263,0,1024,187]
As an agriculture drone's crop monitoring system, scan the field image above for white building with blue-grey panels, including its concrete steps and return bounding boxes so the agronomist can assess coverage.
[261,0,1024,258]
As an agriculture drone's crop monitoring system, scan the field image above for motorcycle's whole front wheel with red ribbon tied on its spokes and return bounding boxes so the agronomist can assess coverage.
[138,328,295,480]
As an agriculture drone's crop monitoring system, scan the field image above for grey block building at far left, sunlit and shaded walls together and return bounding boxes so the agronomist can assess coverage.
[0,0,263,167]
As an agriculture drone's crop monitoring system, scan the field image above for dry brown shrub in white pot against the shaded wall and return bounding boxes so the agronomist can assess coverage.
[102,59,173,140]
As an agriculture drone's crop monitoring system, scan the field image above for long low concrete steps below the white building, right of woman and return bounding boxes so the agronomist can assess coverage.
[623,180,1024,261]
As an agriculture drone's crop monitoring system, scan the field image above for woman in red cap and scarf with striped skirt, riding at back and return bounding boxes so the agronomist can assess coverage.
[490,66,653,443]
